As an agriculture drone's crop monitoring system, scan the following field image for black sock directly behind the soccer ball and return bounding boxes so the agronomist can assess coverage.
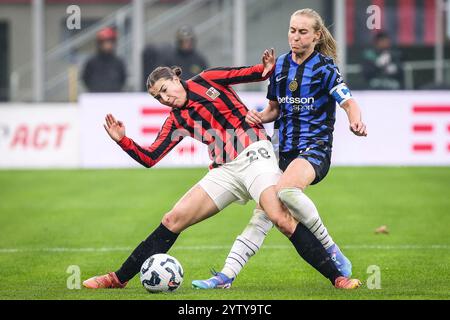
[116,223,178,283]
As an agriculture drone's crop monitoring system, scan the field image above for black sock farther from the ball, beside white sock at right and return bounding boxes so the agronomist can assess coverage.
[289,223,342,285]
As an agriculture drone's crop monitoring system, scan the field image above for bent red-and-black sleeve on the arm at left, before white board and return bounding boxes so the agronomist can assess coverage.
[118,115,184,168]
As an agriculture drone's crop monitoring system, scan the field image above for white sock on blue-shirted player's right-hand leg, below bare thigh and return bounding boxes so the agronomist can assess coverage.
[278,188,334,249]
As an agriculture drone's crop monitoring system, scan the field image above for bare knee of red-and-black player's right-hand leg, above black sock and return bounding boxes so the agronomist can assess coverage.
[259,186,298,237]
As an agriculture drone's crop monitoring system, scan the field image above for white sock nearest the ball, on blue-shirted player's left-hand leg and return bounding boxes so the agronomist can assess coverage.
[222,209,273,278]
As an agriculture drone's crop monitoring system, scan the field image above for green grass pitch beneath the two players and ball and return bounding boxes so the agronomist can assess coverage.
[0,167,450,300]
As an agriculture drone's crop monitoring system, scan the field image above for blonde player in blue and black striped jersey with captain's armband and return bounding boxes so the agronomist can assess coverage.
[193,9,367,289]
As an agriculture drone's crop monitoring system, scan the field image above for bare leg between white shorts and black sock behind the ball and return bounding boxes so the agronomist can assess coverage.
[162,184,219,233]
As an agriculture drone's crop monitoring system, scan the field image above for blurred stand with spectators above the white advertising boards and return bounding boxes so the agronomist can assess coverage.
[0,0,450,102]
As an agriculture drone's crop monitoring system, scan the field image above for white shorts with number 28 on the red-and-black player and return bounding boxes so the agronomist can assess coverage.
[198,140,282,210]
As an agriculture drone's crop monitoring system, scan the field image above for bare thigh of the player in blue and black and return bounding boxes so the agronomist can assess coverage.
[277,158,316,190]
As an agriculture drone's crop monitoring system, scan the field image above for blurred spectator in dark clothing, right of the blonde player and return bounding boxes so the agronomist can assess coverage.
[363,32,403,90]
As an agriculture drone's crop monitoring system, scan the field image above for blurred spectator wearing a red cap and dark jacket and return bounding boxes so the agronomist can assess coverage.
[83,28,126,92]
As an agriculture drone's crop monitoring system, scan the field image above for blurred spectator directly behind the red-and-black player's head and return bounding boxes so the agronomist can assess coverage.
[167,26,208,80]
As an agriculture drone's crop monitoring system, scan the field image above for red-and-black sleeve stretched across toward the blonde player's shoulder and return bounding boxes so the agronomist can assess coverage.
[200,64,274,85]
